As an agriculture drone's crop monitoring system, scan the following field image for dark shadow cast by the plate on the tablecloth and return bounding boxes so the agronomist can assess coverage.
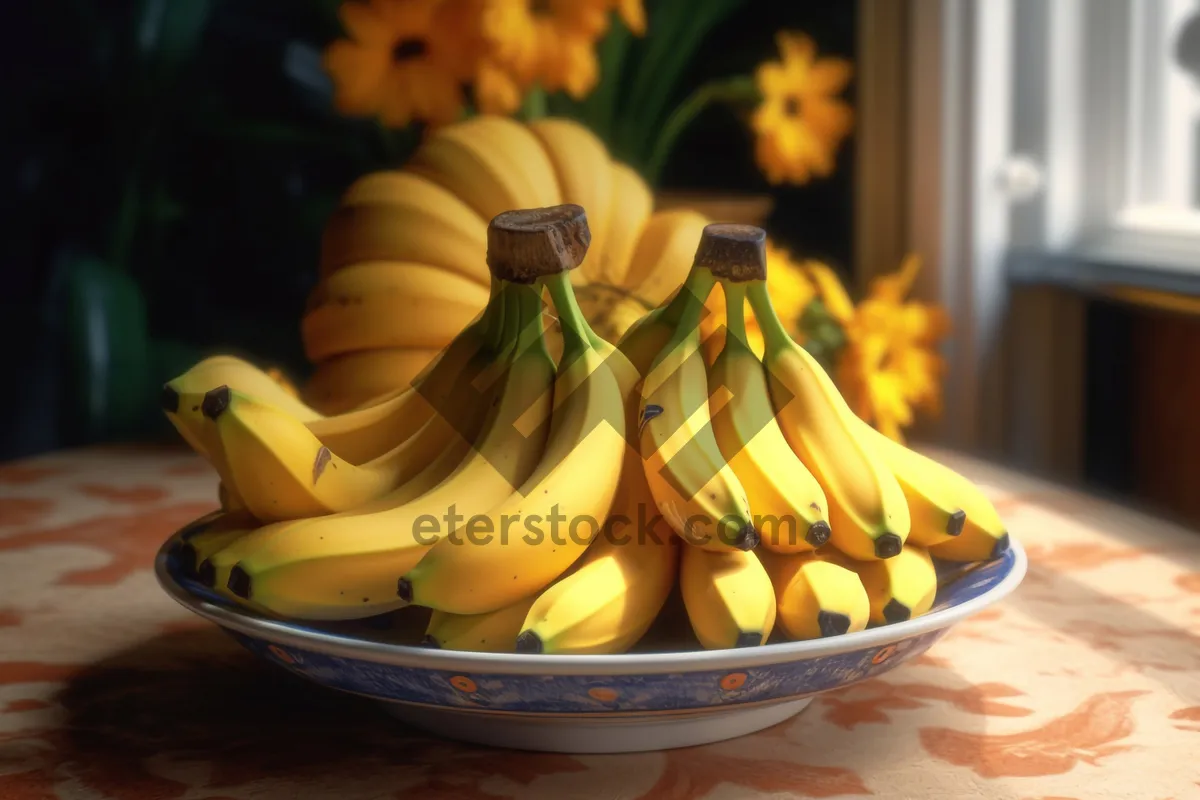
[28,627,1017,800]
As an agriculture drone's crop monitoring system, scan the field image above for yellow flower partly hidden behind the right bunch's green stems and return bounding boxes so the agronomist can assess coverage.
[700,240,817,362]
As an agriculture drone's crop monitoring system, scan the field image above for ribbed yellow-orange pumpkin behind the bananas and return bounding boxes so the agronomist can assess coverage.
[301,115,707,414]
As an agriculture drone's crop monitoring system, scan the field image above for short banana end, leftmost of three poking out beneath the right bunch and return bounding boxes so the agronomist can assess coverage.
[679,547,775,650]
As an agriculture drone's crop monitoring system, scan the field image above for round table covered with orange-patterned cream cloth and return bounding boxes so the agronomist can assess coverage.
[0,447,1200,800]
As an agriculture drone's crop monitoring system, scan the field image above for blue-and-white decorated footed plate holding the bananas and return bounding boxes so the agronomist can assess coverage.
[155,541,1026,753]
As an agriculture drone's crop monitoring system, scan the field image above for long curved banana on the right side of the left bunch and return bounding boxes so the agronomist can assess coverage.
[398,273,625,614]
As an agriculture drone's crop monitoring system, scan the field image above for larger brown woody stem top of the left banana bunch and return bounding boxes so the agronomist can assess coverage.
[487,204,592,283]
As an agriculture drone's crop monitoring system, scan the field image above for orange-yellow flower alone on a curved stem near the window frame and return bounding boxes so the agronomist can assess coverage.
[751,34,853,184]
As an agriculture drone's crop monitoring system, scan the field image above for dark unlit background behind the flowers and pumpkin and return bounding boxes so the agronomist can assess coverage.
[0,0,856,459]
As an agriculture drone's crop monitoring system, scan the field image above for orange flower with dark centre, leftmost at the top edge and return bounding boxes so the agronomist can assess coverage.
[325,0,464,127]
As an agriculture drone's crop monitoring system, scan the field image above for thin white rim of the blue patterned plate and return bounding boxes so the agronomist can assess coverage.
[155,537,1028,675]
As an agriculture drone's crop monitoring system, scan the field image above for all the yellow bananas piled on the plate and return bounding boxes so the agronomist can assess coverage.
[163,204,1008,654]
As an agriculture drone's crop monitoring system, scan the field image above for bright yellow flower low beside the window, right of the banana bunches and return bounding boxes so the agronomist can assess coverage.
[822,255,950,441]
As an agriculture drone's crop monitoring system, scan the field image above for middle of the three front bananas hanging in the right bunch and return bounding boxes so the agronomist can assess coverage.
[708,281,829,553]
